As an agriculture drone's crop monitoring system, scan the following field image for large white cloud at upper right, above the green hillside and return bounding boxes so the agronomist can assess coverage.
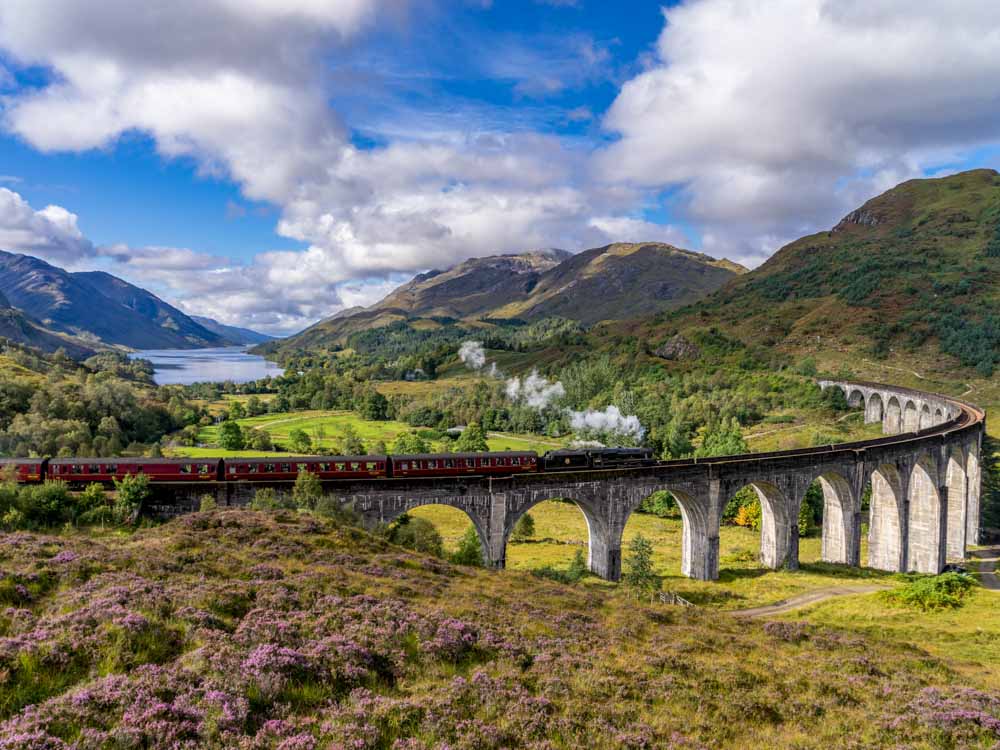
[599,0,1000,262]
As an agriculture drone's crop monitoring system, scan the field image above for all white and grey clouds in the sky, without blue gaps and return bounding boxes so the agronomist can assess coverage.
[0,0,1000,331]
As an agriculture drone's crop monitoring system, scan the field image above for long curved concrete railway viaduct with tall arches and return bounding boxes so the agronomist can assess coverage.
[151,380,985,580]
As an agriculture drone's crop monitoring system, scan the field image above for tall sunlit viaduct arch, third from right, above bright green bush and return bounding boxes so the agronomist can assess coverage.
[906,453,947,573]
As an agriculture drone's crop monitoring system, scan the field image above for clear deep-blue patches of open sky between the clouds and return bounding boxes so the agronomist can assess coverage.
[0,0,663,260]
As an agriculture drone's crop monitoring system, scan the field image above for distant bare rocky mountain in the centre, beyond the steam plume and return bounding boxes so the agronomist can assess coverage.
[262,242,745,353]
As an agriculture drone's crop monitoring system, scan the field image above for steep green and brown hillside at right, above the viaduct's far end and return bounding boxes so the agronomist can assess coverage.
[624,169,1000,376]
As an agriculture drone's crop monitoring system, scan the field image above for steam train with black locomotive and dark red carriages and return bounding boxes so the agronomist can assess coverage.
[0,448,656,485]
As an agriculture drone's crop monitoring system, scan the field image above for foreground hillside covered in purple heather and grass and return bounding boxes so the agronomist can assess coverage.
[0,510,1000,750]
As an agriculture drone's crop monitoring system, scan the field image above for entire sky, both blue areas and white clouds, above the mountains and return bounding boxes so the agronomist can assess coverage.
[0,0,1000,333]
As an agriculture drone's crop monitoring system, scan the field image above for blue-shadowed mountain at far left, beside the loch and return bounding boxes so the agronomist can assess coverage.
[0,252,229,349]
